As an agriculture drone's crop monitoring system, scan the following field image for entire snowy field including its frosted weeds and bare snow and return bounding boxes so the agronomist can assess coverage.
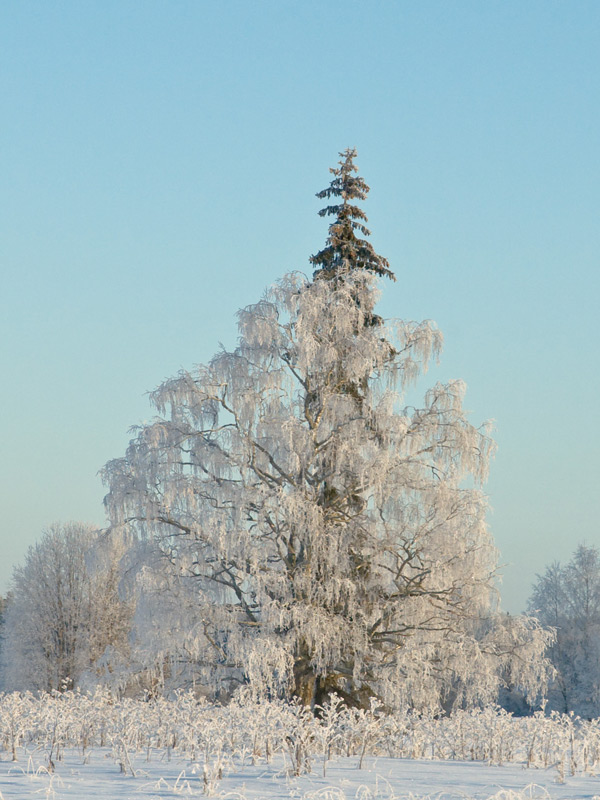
[0,690,600,800]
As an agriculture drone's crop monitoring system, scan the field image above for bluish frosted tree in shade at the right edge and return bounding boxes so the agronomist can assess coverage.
[529,545,600,718]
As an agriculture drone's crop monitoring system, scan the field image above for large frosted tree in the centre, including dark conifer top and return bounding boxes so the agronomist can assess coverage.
[105,150,545,707]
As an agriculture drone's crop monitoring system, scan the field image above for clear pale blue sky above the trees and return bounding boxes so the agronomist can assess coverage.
[0,0,600,613]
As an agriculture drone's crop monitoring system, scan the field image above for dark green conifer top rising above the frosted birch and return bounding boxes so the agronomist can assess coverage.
[310,147,396,280]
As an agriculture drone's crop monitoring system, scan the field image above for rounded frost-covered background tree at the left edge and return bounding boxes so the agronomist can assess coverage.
[2,522,130,691]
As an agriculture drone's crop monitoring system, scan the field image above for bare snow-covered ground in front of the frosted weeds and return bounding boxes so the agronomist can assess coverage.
[0,748,600,800]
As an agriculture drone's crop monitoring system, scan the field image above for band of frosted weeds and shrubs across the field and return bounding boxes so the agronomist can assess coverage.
[0,691,600,788]
